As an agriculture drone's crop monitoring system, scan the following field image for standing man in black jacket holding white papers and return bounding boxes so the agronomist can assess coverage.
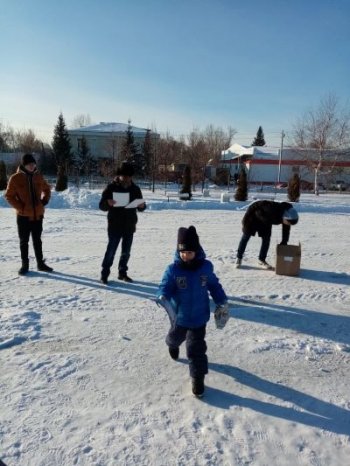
[99,161,146,285]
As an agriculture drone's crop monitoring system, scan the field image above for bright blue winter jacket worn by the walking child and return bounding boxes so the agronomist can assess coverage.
[157,248,227,328]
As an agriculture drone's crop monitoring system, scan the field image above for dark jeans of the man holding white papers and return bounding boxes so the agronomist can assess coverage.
[101,231,134,278]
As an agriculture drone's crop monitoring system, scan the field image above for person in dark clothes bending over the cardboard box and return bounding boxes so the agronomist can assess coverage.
[236,201,299,270]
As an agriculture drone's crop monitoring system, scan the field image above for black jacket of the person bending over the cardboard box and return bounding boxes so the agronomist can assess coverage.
[242,201,293,244]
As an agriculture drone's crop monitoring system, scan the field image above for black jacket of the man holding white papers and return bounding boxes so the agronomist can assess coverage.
[99,178,146,234]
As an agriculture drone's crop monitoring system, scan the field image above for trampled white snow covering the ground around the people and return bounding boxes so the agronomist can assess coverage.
[0,188,350,466]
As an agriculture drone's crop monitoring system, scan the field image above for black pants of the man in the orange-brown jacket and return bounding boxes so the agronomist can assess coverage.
[17,215,43,264]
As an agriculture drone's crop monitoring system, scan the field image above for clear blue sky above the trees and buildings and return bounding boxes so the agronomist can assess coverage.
[0,0,350,144]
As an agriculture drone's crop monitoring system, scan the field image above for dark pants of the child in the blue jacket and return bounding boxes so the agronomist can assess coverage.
[165,324,208,377]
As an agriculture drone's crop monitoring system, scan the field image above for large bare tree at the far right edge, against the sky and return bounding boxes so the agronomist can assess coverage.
[293,94,350,194]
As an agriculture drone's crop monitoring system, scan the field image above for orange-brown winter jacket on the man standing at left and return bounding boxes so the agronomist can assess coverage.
[5,166,51,220]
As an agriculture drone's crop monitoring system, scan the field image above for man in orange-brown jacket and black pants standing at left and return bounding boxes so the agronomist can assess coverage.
[5,154,53,275]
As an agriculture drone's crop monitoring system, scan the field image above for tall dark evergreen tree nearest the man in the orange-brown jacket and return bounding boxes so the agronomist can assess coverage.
[52,113,72,191]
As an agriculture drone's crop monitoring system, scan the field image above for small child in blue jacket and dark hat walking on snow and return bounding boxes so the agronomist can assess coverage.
[157,226,228,397]
